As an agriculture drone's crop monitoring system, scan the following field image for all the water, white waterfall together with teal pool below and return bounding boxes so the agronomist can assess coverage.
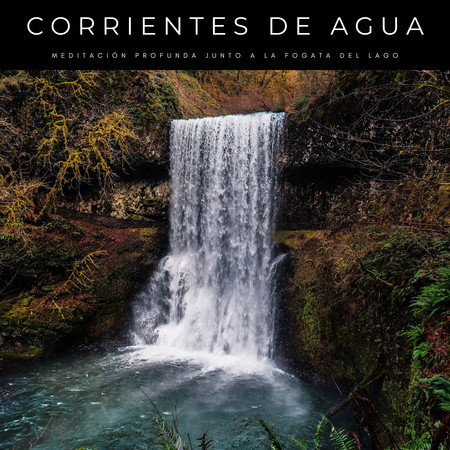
[0,113,356,449]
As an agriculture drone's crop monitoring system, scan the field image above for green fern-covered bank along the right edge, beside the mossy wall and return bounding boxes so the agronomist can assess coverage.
[350,227,450,448]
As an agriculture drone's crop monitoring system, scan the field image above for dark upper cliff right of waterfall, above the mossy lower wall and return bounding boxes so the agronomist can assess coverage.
[280,73,449,229]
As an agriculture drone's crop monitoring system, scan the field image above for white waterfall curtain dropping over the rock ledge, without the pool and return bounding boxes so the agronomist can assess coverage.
[133,113,285,359]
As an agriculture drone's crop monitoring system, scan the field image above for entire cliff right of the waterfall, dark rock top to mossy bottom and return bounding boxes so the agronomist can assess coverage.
[276,74,450,447]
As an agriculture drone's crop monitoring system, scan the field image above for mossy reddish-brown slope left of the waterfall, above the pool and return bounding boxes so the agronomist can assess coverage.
[0,217,165,358]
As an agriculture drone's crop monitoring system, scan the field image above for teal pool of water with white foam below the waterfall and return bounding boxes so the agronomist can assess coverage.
[0,346,351,450]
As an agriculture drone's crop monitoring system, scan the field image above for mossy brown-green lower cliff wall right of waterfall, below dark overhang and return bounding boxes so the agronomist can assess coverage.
[275,226,450,442]
